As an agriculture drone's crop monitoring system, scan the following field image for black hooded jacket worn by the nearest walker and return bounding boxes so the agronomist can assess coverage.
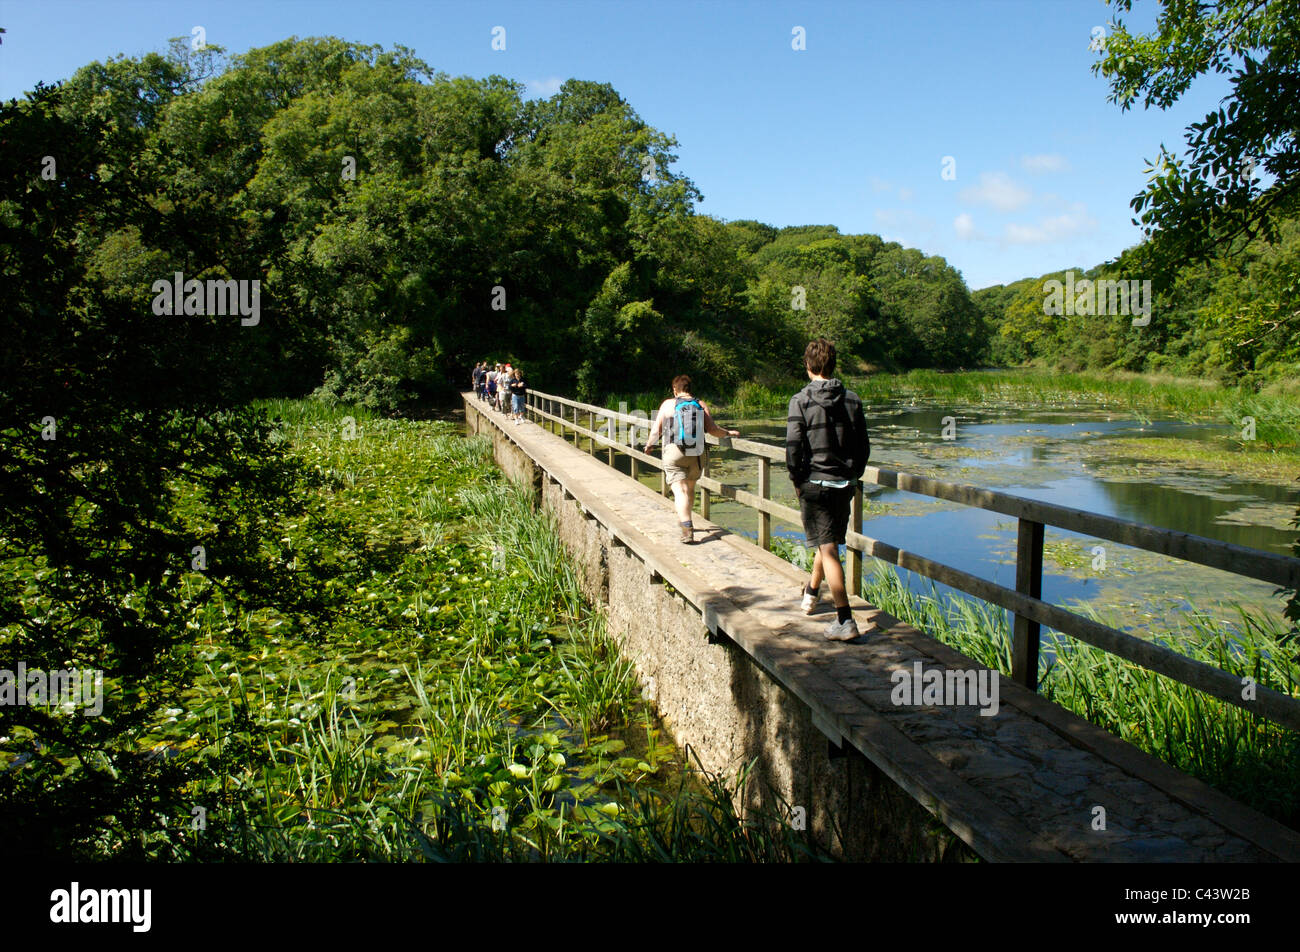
[785,380,871,486]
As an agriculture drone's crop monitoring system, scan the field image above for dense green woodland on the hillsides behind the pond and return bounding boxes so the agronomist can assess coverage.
[3,39,1300,411]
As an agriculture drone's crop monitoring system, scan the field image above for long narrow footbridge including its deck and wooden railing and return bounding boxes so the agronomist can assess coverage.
[463,391,1300,862]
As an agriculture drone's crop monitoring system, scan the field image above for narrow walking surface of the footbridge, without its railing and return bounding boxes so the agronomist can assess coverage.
[464,394,1300,862]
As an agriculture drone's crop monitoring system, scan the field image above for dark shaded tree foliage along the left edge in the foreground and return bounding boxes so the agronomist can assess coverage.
[0,87,356,858]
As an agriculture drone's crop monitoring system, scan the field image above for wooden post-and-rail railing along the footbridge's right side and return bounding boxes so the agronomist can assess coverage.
[528,390,1300,731]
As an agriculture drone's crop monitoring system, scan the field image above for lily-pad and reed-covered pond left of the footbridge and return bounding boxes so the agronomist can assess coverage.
[0,401,819,861]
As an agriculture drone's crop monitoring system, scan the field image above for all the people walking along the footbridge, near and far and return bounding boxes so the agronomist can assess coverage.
[473,338,871,641]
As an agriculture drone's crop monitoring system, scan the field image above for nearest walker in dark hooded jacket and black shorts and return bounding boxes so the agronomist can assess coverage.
[785,338,871,641]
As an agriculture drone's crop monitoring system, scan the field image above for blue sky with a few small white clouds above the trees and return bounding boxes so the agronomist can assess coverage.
[0,0,1227,289]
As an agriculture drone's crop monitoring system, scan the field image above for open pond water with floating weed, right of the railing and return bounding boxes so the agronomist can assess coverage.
[651,402,1300,633]
